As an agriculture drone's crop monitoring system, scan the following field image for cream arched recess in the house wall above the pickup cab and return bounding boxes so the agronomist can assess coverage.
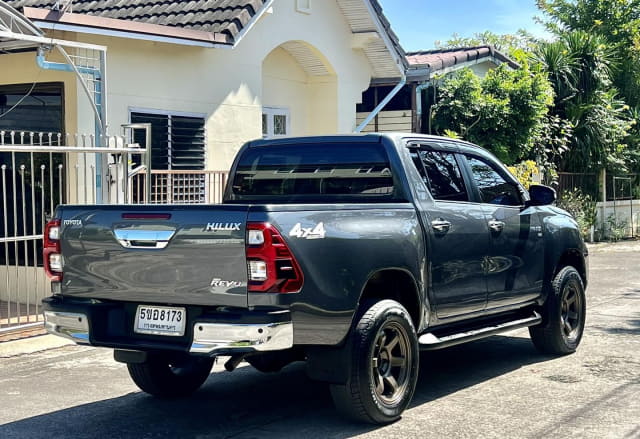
[262,41,338,138]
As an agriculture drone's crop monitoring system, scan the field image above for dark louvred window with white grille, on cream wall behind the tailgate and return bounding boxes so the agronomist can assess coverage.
[131,111,206,203]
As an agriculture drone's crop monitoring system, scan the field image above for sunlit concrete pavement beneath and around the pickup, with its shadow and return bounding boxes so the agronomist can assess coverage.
[0,243,640,439]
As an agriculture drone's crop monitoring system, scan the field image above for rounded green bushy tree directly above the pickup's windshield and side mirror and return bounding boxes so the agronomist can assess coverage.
[433,63,553,164]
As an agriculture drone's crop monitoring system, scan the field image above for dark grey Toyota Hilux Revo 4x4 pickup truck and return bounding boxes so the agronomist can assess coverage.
[44,134,588,423]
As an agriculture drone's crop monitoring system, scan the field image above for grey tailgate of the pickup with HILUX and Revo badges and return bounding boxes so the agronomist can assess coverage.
[56,205,248,307]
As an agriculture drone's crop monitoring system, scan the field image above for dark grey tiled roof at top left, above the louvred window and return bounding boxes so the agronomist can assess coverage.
[7,0,266,41]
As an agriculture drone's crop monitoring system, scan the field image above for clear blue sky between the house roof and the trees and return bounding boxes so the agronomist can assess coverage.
[378,0,548,52]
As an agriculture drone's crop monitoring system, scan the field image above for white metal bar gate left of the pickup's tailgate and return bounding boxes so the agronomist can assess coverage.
[0,124,151,335]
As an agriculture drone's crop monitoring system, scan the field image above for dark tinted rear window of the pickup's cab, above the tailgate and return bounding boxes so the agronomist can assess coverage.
[232,143,393,202]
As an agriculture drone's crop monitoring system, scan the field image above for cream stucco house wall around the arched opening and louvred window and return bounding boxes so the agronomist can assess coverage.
[52,0,372,170]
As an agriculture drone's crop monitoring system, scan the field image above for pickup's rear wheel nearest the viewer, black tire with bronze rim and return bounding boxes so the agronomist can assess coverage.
[330,300,419,424]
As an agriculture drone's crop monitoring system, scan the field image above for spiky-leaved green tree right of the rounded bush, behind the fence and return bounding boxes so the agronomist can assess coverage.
[535,31,633,172]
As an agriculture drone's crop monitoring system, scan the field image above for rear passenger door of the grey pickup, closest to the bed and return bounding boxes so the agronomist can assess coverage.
[410,145,489,319]
